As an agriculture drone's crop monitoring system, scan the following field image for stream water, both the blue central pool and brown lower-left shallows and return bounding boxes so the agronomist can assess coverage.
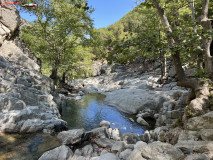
[0,94,145,160]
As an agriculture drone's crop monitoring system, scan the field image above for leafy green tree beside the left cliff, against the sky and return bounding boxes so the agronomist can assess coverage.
[22,0,93,84]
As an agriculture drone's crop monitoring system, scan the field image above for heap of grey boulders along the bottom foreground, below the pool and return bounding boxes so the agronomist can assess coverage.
[39,123,183,160]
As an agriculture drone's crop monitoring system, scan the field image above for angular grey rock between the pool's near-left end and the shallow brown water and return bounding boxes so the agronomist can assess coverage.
[57,129,84,145]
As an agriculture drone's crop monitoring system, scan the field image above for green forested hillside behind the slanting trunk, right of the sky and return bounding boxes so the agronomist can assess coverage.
[96,1,213,64]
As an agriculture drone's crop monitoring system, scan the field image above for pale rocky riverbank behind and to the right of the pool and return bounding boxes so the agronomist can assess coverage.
[55,61,213,160]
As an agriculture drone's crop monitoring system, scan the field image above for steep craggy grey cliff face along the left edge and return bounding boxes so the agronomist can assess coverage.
[0,0,66,133]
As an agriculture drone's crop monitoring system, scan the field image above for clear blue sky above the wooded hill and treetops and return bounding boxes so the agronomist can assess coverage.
[20,0,136,29]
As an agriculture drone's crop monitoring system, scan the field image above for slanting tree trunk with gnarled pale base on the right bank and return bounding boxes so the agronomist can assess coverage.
[152,0,213,124]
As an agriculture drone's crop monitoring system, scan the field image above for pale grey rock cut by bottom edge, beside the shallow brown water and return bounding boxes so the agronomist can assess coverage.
[39,145,73,160]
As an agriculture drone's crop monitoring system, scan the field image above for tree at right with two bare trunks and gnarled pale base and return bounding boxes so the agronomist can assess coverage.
[152,0,213,120]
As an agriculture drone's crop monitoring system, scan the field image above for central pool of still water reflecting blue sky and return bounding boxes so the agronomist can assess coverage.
[62,94,145,134]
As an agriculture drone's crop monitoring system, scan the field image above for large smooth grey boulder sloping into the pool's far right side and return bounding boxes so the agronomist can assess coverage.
[105,89,169,114]
